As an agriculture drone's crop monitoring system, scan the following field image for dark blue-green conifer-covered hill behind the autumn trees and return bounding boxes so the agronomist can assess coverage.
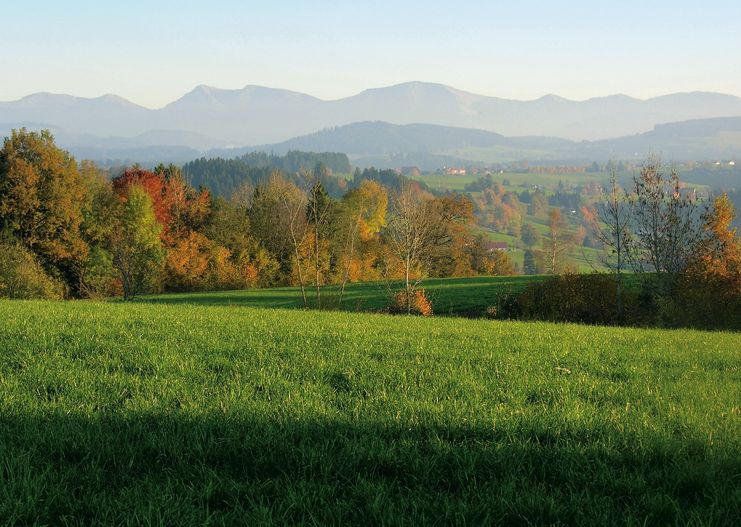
[183,151,352,196]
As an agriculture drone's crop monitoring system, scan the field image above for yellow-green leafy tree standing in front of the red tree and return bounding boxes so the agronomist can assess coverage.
[112,185,165,300]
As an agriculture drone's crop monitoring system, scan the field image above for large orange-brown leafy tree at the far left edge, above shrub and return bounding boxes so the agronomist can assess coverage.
[0,128,88,293]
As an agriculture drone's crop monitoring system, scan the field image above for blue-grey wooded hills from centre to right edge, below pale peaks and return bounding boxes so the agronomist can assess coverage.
[240,117,741,169]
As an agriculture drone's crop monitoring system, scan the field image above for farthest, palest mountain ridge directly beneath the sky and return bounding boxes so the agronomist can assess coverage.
[0,82,741,148]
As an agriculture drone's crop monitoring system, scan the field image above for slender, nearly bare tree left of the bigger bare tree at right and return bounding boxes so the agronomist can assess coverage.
[588,169,632,320]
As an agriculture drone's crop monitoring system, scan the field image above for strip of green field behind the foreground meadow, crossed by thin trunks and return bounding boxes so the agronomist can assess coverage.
[141,276,543,317]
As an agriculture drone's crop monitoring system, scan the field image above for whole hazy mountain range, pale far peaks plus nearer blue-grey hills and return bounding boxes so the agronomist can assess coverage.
[0,82,741,162]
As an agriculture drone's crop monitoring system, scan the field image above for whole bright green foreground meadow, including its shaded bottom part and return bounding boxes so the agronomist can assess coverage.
[0,301,741,525]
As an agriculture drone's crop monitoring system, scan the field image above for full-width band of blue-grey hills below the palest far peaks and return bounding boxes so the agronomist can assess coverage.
[5,117,741,169]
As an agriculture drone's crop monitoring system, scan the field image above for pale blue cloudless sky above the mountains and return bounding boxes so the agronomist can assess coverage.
[0,0,741,108]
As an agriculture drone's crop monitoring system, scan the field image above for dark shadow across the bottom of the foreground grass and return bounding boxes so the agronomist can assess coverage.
[0,412,741,525]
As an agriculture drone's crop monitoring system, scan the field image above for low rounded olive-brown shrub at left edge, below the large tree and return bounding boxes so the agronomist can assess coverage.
[0,242,65,299]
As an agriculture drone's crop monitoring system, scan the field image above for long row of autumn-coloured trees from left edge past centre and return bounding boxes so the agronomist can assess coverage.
[0,129,513,311]
